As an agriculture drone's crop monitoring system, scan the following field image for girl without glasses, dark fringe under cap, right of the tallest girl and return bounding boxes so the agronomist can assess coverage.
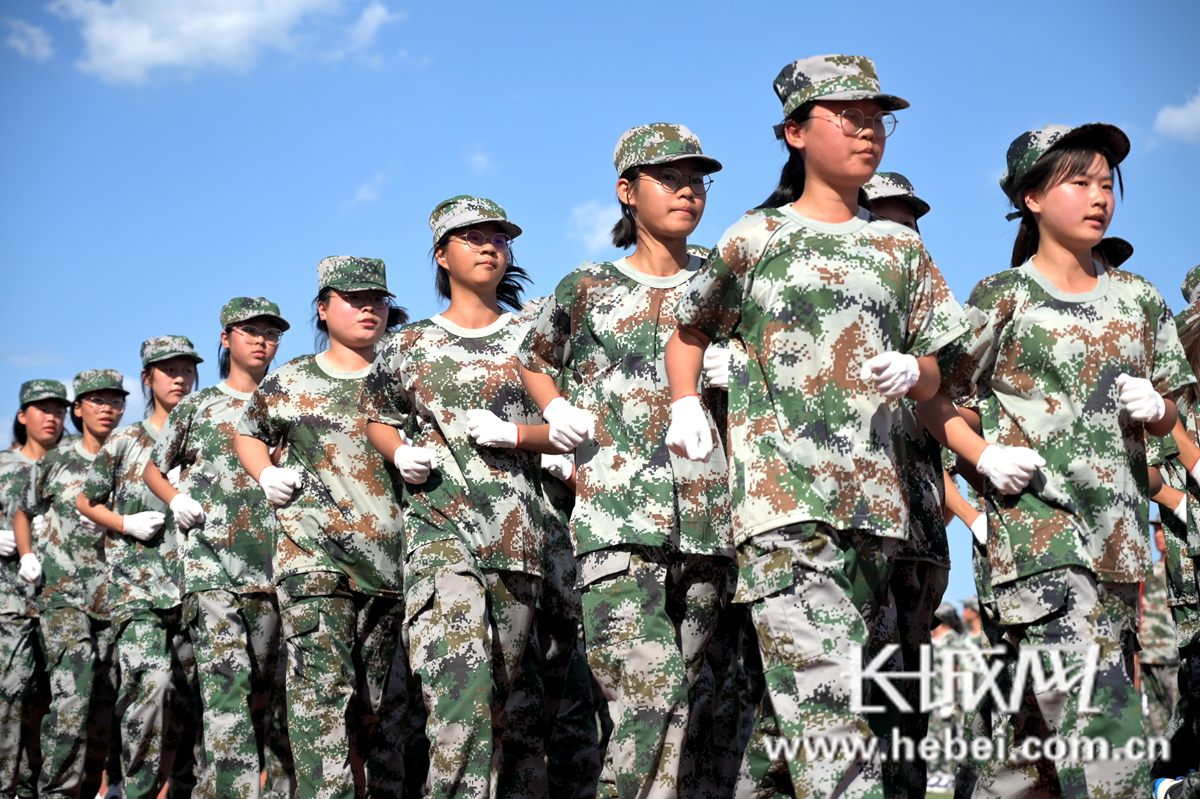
[935,124,1195,797]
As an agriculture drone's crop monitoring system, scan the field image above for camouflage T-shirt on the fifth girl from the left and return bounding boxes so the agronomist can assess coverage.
[238,354,404,596]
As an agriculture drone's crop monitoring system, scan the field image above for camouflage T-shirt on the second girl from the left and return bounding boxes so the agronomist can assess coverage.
[20,441,109,619]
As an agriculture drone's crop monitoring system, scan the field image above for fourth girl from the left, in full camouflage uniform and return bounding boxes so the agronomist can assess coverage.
[145,296,295,799]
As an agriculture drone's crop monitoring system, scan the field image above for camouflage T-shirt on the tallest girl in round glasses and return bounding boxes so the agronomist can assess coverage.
[676,205,966,543]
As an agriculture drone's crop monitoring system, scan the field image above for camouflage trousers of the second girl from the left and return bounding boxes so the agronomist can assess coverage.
[38,607,116,799]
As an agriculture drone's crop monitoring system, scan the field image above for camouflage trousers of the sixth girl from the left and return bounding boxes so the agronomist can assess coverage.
[404,539,545,799]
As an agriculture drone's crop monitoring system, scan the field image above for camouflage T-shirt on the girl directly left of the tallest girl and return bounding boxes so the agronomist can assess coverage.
[520,258,732,557]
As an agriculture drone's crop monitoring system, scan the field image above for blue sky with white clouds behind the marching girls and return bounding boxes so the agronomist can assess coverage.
[0,0,1200,599]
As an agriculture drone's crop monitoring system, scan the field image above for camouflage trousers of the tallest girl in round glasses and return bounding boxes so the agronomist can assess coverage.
[734,522,896,799]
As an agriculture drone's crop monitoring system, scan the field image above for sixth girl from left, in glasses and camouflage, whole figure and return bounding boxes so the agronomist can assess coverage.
[359,196,558,797]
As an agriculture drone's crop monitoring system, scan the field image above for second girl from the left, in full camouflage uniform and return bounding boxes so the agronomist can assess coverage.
[14,370,128,799]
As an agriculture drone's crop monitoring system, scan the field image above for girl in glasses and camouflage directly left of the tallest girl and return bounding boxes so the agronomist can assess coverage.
[521,124,732,797]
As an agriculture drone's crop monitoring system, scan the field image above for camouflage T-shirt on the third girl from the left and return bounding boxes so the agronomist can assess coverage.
[83,421,182,611]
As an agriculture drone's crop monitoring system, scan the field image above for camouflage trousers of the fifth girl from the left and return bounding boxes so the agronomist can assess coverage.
[278,571,407,799]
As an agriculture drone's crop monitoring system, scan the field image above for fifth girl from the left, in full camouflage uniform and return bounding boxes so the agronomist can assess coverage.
[234,256,407,799]
